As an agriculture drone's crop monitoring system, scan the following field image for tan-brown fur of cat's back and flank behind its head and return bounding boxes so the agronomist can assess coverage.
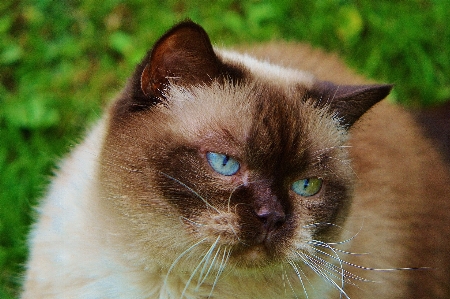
[244,43,450,298]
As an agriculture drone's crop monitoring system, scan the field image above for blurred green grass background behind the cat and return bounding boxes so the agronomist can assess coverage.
[0,0,450,298]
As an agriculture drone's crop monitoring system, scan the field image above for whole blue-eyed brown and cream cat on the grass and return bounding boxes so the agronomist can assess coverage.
[22,21,450,299]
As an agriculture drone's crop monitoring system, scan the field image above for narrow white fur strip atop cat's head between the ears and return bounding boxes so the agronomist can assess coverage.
[214,48,315,88]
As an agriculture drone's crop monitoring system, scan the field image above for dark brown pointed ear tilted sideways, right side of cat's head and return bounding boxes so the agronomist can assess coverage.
[309,81,393,127]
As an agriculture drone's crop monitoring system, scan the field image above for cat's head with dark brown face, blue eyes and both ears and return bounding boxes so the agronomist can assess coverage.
[100,22,391,267]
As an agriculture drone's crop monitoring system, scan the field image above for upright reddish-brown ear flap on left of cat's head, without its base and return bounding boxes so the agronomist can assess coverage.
[140,21,221,98]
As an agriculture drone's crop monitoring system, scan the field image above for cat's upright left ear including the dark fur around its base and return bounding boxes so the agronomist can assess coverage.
[115,20,243,115]
